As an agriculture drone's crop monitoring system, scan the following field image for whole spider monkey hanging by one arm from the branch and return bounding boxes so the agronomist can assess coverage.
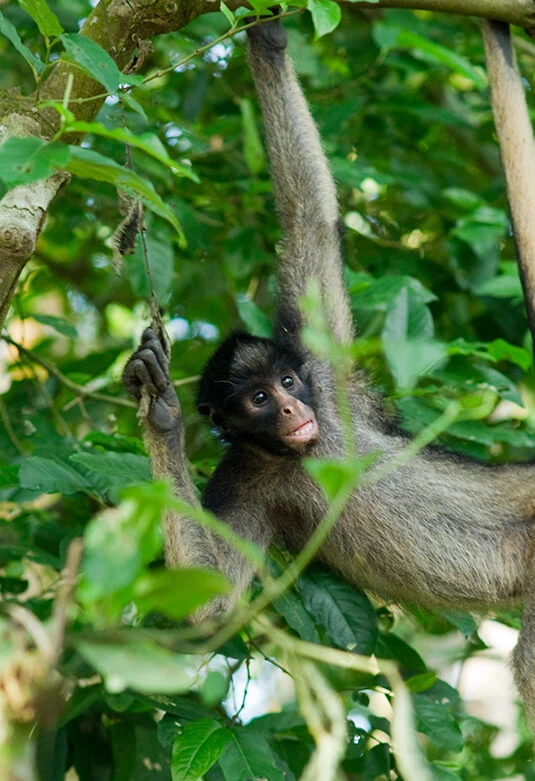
[124,20,535,726]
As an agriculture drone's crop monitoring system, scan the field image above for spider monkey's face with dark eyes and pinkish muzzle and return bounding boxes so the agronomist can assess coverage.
[235,370,319,454]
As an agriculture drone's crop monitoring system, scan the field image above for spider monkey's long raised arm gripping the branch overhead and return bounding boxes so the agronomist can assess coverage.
[249,19,353,343]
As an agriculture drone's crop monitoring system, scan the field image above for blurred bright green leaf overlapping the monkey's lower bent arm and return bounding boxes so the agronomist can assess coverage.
[134,567,230,620]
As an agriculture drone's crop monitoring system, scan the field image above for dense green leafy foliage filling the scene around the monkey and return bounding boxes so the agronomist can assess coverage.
[0,0,535,781]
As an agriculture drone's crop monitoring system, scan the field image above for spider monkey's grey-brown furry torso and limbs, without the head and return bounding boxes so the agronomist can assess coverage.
[125,16,535,732]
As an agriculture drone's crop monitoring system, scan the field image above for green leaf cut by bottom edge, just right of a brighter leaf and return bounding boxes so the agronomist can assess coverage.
[219,730,288,781]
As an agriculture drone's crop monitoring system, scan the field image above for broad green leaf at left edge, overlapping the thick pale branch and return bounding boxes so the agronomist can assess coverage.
[0,136,70,187]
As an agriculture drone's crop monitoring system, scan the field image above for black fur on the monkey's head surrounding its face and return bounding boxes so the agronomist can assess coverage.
[197,332,312,452]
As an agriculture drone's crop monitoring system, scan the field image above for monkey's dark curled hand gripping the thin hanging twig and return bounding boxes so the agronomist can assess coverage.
[123,328,182,434]
